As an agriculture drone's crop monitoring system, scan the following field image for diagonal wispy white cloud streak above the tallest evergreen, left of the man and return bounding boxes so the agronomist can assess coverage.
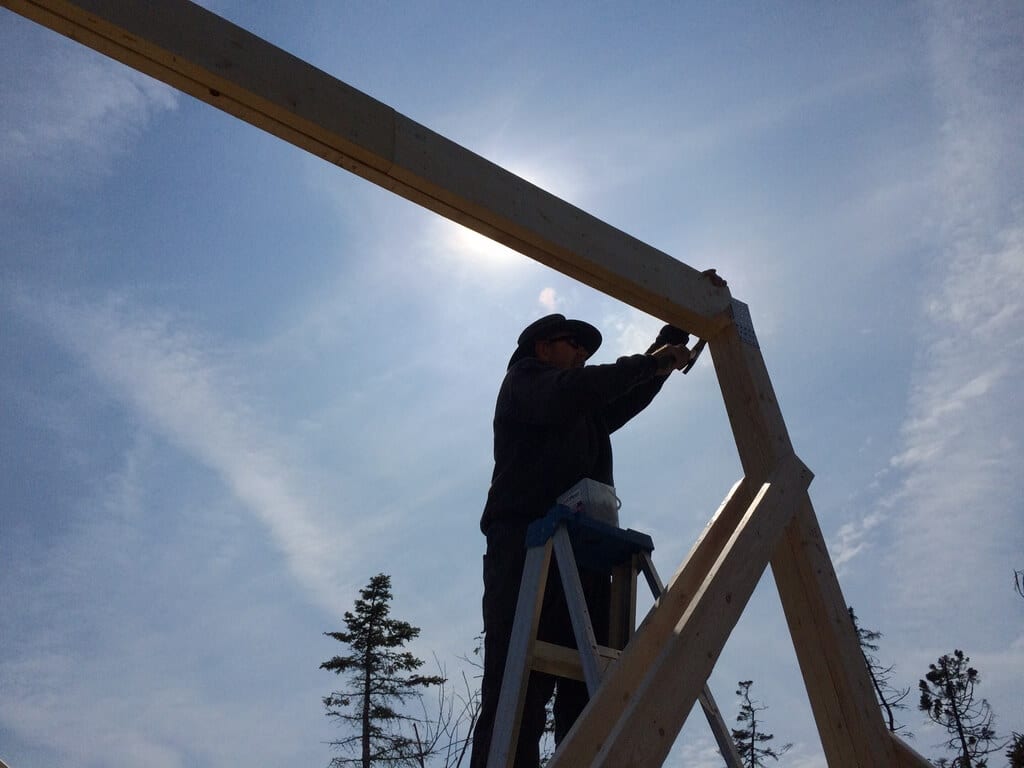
[17,296,352,609]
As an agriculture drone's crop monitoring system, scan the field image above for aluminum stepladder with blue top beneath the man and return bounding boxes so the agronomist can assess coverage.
[487,505,741,768]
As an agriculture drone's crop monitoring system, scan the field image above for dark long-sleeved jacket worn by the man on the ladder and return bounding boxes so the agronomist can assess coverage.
[480,354,665,534]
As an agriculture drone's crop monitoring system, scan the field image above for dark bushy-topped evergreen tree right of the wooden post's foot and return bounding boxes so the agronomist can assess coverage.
[918,649,999,768]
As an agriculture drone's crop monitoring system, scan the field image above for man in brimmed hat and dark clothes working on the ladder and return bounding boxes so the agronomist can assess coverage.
[471,309,700,768]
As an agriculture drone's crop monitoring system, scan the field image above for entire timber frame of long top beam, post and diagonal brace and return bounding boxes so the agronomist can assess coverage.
[0,0,929,768]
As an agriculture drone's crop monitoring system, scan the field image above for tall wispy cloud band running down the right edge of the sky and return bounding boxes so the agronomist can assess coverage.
[835,3,1024,609]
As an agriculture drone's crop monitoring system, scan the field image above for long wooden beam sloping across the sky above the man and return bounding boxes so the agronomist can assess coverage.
[0,0,730,338]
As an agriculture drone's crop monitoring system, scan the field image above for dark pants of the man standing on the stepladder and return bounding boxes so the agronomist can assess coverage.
[470,523,610,768]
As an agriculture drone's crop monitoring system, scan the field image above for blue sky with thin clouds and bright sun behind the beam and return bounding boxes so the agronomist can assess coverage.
[0,0,1024,768]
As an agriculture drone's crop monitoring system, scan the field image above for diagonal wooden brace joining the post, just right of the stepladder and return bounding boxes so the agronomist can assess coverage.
[549,454,811,768]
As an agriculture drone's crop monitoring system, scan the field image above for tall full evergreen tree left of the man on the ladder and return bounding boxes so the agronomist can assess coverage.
[321,573,444,768]
